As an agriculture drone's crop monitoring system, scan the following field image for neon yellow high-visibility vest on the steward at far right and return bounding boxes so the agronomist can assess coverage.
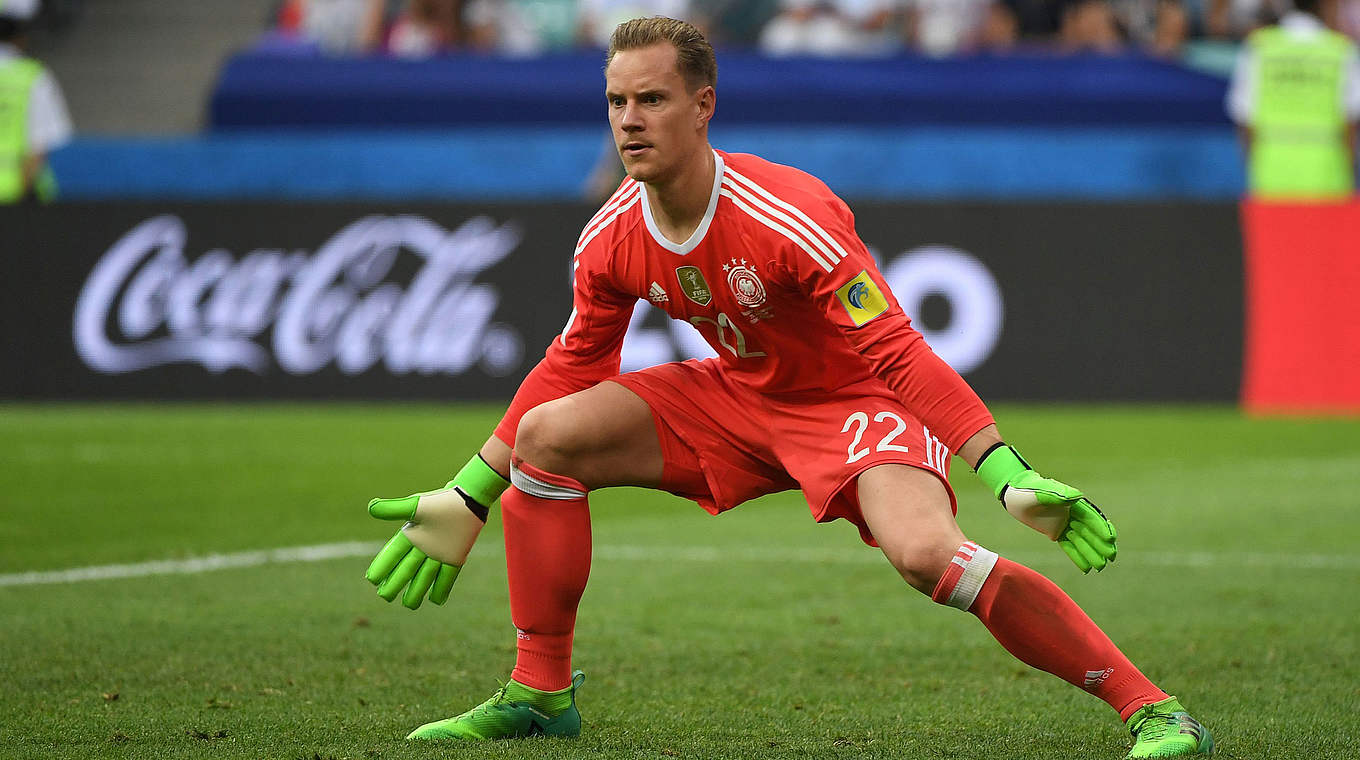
[1247,27,1355,198]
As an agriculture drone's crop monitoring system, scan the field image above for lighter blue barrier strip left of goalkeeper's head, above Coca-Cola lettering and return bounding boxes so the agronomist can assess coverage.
[52,128,605,200]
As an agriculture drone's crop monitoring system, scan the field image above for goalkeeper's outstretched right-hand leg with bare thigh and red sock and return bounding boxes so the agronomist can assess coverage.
[858,465,1212,755]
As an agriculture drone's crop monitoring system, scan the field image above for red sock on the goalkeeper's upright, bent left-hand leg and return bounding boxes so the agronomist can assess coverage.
[500,457,590,691]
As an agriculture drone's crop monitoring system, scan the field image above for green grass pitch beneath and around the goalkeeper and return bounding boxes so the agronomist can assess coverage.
[0,405,1360,760]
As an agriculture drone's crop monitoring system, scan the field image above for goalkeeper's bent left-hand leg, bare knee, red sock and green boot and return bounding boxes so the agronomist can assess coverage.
[408,382,664,738]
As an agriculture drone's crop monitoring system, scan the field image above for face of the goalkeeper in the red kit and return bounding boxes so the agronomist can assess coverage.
[604,42,714,182]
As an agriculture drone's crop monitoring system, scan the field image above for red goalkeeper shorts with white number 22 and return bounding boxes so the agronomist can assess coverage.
[611,359,957,545]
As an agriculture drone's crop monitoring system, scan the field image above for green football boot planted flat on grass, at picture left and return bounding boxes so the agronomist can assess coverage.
[407,670,586,740]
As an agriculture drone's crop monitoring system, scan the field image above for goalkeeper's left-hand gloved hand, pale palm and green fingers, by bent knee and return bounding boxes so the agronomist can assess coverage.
[364,483,487,609]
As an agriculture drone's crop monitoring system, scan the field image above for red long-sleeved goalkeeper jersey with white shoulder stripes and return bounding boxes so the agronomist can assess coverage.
[496,151,993,450]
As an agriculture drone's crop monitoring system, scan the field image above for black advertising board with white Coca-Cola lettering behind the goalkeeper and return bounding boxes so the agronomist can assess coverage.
[0,203,1242,400]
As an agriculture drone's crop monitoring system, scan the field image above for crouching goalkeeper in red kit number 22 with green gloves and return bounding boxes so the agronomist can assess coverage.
[369,18,1213,757]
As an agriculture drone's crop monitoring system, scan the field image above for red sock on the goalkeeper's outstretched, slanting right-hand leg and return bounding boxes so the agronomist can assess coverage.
[932,541,1167,721]
